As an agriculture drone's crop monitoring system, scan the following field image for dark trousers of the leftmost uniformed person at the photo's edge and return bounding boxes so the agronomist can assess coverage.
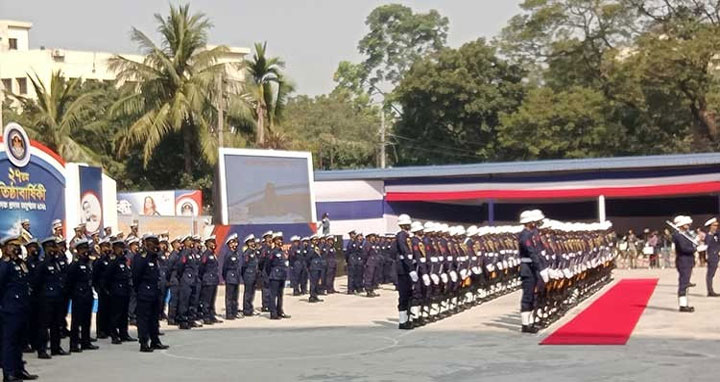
[0,313,27,377]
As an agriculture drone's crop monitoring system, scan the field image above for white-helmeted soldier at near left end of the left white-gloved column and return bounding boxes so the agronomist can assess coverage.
[395,214,419,330]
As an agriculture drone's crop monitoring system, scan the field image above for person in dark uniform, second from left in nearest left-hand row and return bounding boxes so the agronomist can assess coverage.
[32,240,69,359]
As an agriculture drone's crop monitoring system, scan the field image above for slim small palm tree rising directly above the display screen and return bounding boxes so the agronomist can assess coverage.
[245,42,285,146]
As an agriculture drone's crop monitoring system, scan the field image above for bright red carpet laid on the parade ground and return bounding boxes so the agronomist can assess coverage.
[540,279,658,345]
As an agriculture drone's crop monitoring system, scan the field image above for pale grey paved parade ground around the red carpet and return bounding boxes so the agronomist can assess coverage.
[26,269,720,382]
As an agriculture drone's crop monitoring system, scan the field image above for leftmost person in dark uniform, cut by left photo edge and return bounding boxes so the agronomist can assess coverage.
[0,237,38,382]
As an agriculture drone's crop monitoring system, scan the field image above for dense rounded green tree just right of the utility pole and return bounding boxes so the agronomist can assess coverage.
[394,39,525,164]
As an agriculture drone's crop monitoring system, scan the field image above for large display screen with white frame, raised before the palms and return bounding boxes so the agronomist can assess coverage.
[220,149,315,224]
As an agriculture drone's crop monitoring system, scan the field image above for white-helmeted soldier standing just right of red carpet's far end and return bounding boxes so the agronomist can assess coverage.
[673,215,697,313]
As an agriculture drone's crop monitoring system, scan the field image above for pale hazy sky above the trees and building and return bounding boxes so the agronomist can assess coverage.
[0,0,521,95]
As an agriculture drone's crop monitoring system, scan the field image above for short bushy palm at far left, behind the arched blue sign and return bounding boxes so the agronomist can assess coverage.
[10,71,103,163]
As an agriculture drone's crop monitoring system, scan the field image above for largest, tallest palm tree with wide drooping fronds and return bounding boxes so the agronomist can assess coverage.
[110,5,235,173]
